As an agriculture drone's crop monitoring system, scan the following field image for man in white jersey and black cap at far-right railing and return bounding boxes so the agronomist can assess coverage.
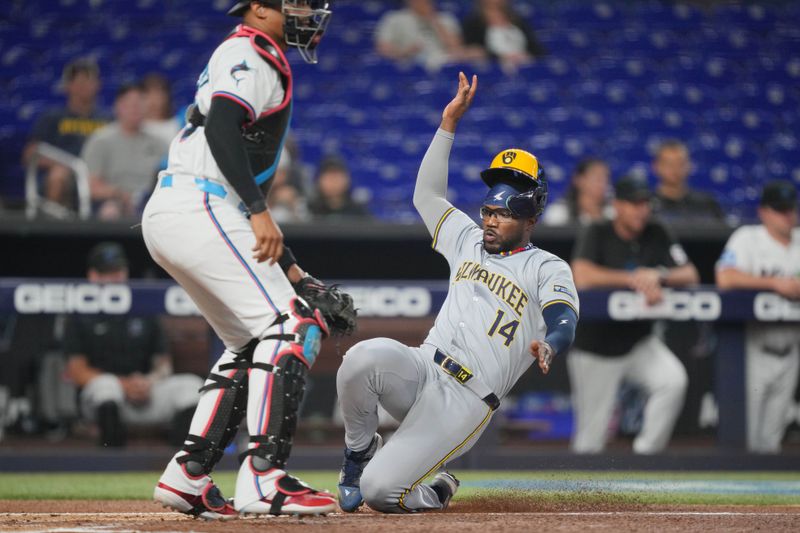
[717,180,800,453]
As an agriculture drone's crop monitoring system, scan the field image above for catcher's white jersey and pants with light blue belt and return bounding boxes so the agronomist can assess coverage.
[142,26,332,513]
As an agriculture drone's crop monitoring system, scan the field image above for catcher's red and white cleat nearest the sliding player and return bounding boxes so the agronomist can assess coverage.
[233,458,336,515]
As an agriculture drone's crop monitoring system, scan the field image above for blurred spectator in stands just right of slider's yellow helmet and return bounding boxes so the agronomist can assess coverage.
[543,157,613,226]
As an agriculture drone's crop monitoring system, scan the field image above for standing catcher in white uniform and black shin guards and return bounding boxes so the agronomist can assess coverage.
[142,0,356,519]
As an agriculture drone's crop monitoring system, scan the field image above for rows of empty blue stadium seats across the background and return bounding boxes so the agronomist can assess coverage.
[0,0,800,221]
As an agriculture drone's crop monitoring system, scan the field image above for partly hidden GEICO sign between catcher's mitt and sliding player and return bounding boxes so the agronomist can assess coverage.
[342,286,431,317]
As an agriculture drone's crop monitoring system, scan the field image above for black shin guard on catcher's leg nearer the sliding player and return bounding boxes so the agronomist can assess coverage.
[240,349,308,472]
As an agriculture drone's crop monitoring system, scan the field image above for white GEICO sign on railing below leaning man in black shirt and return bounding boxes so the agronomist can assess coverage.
[608,290,722,320]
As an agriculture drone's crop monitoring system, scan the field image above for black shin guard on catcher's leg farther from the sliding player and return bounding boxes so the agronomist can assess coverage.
[177,348,257,476]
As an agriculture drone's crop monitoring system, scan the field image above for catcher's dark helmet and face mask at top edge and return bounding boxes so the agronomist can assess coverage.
[228,0,332,63]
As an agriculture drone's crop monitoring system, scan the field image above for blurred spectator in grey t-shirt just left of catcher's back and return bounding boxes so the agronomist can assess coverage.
[81,84,168,220]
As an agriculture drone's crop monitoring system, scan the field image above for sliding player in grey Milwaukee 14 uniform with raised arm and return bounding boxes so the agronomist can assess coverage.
[336,73,578,513]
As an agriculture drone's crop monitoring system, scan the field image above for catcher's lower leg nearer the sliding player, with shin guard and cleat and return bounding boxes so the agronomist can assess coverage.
[234,298,336,514]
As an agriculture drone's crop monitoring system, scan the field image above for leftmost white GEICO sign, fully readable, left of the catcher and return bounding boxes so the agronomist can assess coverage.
[14,283,131,315]
